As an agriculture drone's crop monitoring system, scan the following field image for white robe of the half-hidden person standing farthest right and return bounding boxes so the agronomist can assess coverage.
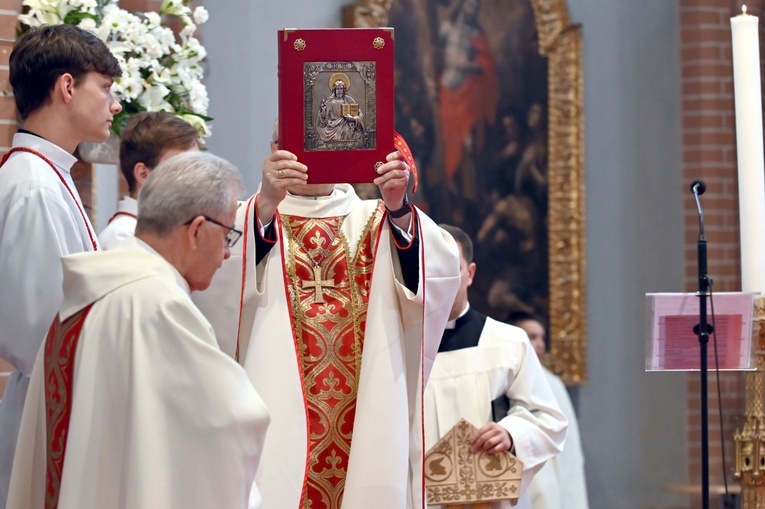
[529,369,589,509]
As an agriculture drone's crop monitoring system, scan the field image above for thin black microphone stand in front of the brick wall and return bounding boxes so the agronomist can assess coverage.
[691,180,712,509]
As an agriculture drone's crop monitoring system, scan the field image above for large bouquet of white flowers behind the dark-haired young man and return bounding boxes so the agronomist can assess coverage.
[18,0,212,138]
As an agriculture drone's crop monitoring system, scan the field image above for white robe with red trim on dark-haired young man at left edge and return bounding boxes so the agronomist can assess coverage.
[0,133,95,508]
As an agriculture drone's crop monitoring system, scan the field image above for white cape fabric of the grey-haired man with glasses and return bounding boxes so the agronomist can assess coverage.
[8,238,268,509]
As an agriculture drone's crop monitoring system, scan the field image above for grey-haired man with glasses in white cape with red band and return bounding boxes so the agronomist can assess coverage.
[8,152,269,509]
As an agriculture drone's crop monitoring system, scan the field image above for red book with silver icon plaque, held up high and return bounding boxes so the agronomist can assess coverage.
[278,28,394,184]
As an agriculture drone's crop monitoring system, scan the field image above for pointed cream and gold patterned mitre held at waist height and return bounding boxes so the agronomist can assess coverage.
[425,419,523,509]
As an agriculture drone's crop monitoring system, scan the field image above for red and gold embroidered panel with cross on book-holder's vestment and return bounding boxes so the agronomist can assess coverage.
[282,208,383,509]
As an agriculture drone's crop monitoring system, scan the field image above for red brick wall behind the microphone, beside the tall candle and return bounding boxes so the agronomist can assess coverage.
[678,0,765,507]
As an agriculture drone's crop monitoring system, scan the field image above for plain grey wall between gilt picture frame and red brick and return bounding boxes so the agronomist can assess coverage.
[569,0,687,509]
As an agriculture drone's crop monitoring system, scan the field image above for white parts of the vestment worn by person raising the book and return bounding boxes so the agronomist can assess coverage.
[195,184,459,509]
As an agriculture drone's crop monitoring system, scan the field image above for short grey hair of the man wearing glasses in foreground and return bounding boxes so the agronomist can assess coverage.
[135,152,244,236]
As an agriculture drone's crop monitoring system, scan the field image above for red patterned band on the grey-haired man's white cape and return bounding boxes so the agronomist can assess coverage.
[44,304,93,509]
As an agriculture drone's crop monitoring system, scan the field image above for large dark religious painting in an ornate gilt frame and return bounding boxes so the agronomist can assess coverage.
[345,0,586,384]
